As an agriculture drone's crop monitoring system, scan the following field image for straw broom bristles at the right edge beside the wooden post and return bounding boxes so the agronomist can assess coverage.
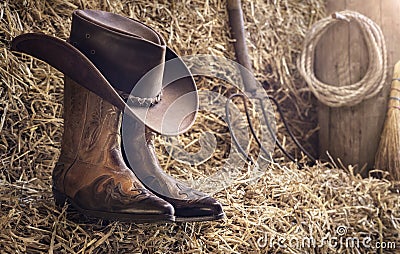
[375,61,400,181]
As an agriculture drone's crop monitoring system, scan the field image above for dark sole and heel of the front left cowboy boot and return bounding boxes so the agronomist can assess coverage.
[53,188,175,223]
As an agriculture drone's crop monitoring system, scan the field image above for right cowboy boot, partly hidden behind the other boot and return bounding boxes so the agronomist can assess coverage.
[123,118,224,222]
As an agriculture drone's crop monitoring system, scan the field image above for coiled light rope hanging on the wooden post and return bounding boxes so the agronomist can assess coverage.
[298,11,387,107]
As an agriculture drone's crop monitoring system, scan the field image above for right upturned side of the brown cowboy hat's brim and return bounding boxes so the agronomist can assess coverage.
[125,48,199,135]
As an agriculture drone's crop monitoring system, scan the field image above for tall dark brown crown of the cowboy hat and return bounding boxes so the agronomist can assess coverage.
[69,10,166,98]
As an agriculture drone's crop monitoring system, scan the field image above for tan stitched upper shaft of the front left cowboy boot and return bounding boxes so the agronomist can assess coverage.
[60,77,121,166]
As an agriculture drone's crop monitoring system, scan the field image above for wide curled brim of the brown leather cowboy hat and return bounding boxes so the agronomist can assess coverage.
[11,33,198,135]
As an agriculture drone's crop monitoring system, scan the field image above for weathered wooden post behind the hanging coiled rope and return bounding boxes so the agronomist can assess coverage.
[314,0,400,176]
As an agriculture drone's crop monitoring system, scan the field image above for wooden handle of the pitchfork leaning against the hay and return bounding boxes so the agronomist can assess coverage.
[227,0,257,93]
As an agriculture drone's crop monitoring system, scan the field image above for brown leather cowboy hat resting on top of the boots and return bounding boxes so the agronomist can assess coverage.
[11,10,198,135]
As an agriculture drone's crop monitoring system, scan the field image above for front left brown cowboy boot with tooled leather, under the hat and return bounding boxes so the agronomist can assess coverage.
[53,77,174,222]
